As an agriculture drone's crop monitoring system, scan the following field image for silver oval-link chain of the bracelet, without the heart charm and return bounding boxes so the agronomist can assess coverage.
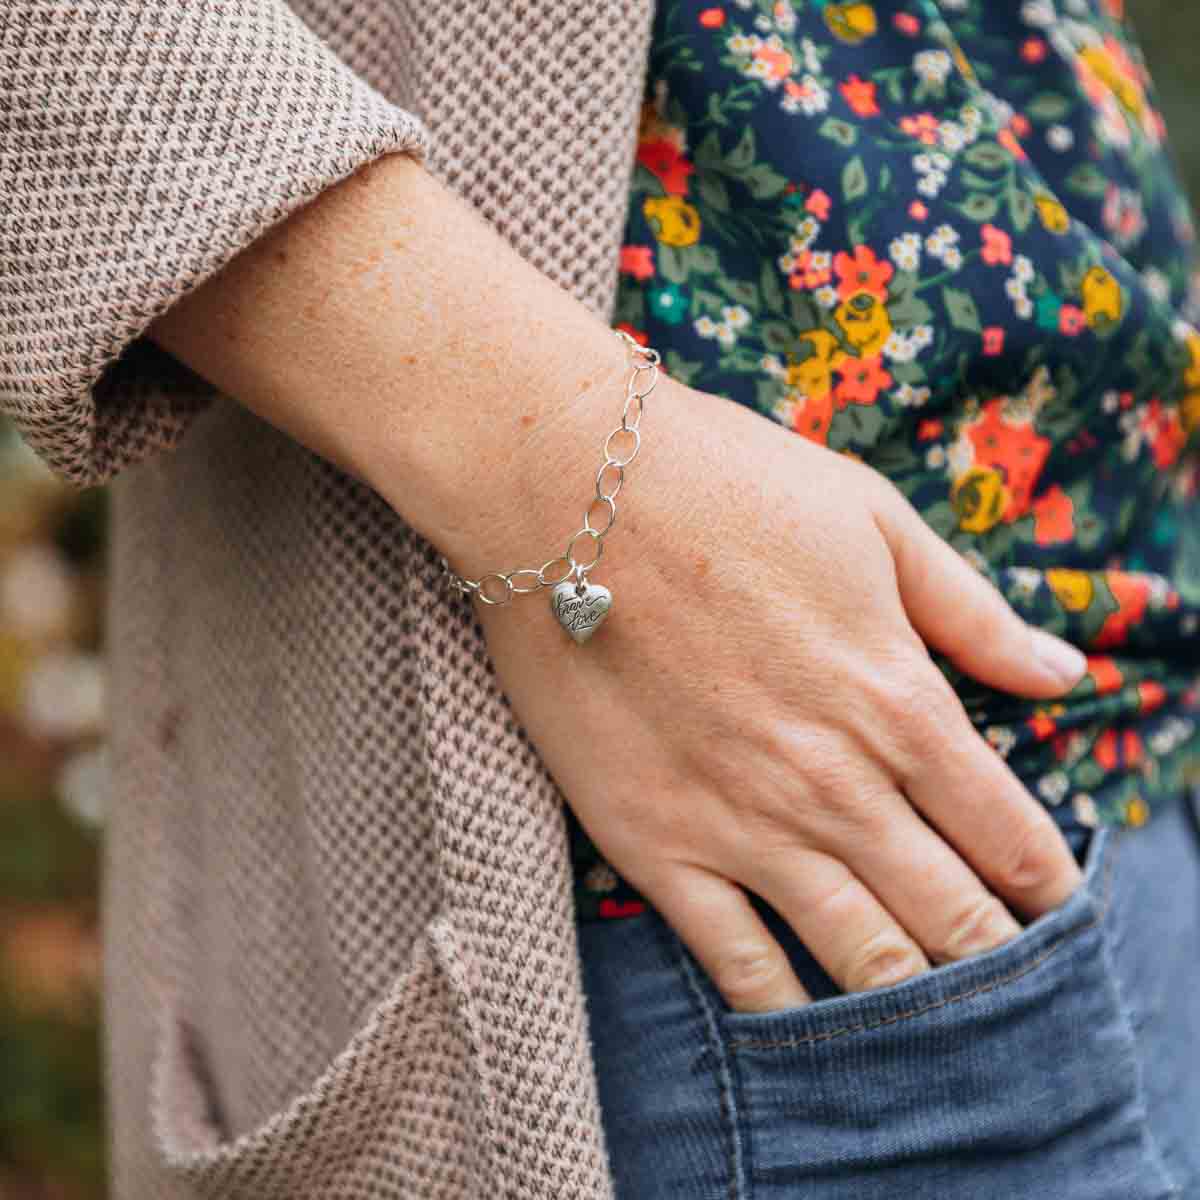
[442,329,661,605]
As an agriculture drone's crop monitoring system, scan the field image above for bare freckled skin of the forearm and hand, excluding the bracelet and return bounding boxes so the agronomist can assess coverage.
[142,147,1080,1010]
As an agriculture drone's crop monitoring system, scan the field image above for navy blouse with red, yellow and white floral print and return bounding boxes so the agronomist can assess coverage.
[568,0,1200,920]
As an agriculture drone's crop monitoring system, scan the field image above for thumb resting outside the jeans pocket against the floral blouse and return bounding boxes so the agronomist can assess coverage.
[875,492,1087,700]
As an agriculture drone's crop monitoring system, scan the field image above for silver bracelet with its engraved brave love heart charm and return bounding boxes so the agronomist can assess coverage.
[442,329,661,644]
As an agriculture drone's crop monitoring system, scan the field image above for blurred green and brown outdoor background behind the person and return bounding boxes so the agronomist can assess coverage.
[0,0,1200,1200]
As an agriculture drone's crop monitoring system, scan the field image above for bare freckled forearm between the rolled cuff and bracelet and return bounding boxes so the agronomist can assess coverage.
[149,148,628,574]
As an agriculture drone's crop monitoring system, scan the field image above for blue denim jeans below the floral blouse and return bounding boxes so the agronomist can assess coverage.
[580,793,1200,1200]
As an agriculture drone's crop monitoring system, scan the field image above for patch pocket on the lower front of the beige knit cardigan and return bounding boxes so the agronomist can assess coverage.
[150,918,491,1200]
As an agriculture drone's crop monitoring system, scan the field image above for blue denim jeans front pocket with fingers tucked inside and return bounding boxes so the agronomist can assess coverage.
[680,828,1176,1200]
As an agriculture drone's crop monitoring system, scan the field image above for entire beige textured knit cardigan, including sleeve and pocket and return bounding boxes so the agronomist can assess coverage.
[0,0,653,1200]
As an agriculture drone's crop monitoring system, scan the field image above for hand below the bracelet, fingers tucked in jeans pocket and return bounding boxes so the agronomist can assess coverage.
[468,378,1086,1012]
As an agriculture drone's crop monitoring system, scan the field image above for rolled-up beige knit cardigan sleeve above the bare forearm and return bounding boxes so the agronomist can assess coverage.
[0,0,430,487]
